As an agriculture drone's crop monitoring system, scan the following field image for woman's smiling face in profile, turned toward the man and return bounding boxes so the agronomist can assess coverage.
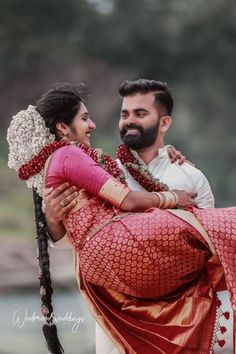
[64,103,96,146]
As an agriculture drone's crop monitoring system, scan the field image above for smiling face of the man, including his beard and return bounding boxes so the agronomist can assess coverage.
[119,93,159,150]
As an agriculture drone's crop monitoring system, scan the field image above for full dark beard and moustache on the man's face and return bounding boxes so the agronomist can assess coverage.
[120,120,159,150]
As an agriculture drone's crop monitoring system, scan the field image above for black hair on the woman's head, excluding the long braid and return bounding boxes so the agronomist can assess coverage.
[36,82,88,140]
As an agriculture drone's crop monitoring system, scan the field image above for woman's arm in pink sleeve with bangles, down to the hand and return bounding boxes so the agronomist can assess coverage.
[47,146,194,211]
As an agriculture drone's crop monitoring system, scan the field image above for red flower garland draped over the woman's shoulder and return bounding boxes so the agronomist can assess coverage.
[18,140,125,183]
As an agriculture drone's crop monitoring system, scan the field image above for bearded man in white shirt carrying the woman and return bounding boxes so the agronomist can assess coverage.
[46,80,232,354]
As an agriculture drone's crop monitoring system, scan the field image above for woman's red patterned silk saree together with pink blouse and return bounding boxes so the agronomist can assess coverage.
[47,147,236,354]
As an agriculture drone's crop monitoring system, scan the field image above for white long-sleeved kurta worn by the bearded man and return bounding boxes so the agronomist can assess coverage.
[50,146,233,354]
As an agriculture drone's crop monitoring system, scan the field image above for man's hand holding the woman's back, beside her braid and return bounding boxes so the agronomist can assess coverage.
[44,183,78,241]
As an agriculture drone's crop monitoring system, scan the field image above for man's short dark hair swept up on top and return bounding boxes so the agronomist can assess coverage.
[119,79,174,115]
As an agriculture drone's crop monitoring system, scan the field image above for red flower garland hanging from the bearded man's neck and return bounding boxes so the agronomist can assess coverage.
[116,144,169,192]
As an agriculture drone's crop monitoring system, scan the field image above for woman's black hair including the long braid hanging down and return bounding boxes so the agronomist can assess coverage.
[33,83,88,354]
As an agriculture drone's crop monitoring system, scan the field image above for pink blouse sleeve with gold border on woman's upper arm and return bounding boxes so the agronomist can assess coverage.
[47,145,129,207]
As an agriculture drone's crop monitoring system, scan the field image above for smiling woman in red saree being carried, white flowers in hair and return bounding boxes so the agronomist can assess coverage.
[8,84,236,353]
